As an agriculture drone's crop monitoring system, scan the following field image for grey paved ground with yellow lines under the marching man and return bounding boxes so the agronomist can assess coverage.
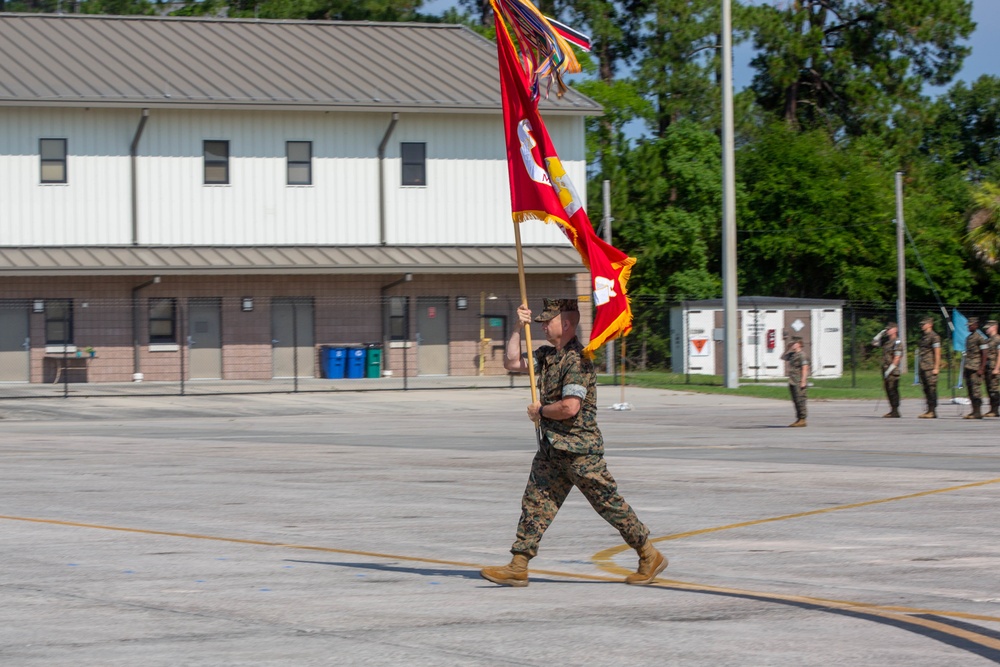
[0,388,1000,667]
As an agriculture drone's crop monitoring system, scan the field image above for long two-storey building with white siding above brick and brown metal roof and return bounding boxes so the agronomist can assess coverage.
[0,14,601,382]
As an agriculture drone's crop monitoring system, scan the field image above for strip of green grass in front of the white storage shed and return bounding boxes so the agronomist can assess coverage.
[598,369,965,400]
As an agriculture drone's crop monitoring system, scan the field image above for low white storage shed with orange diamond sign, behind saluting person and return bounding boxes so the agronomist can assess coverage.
[670,296,844,379]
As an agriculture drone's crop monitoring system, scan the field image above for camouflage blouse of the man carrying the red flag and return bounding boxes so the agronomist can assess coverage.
[535,338,604,454]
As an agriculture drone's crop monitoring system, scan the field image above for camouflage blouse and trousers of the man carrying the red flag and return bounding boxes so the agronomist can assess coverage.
[510,338,649,558]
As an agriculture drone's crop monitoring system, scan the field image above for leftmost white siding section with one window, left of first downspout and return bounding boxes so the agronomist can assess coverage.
[0,108,133,246]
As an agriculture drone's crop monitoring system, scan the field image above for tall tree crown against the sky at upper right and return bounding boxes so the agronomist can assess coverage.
[750,0,975,136]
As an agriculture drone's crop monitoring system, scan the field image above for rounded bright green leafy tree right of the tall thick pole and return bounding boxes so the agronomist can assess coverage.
[736,122,895,301]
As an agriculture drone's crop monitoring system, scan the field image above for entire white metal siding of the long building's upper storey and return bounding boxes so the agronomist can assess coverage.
[0,109,586,246]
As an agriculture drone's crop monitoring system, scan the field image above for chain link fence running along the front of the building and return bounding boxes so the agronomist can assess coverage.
[0,292,1000,399]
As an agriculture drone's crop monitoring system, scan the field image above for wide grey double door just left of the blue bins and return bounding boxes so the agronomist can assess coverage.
[271,297,316,378]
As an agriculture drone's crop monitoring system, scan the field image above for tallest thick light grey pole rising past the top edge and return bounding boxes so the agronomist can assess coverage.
[722,0,740,389]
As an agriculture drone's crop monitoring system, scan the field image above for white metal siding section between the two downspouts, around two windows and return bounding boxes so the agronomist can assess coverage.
[139,112,389,245]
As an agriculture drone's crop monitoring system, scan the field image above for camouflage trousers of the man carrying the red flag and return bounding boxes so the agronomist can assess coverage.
[510,447,649,558]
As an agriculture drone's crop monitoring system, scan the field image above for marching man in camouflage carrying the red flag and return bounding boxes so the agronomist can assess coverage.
[479,299,667,587]
